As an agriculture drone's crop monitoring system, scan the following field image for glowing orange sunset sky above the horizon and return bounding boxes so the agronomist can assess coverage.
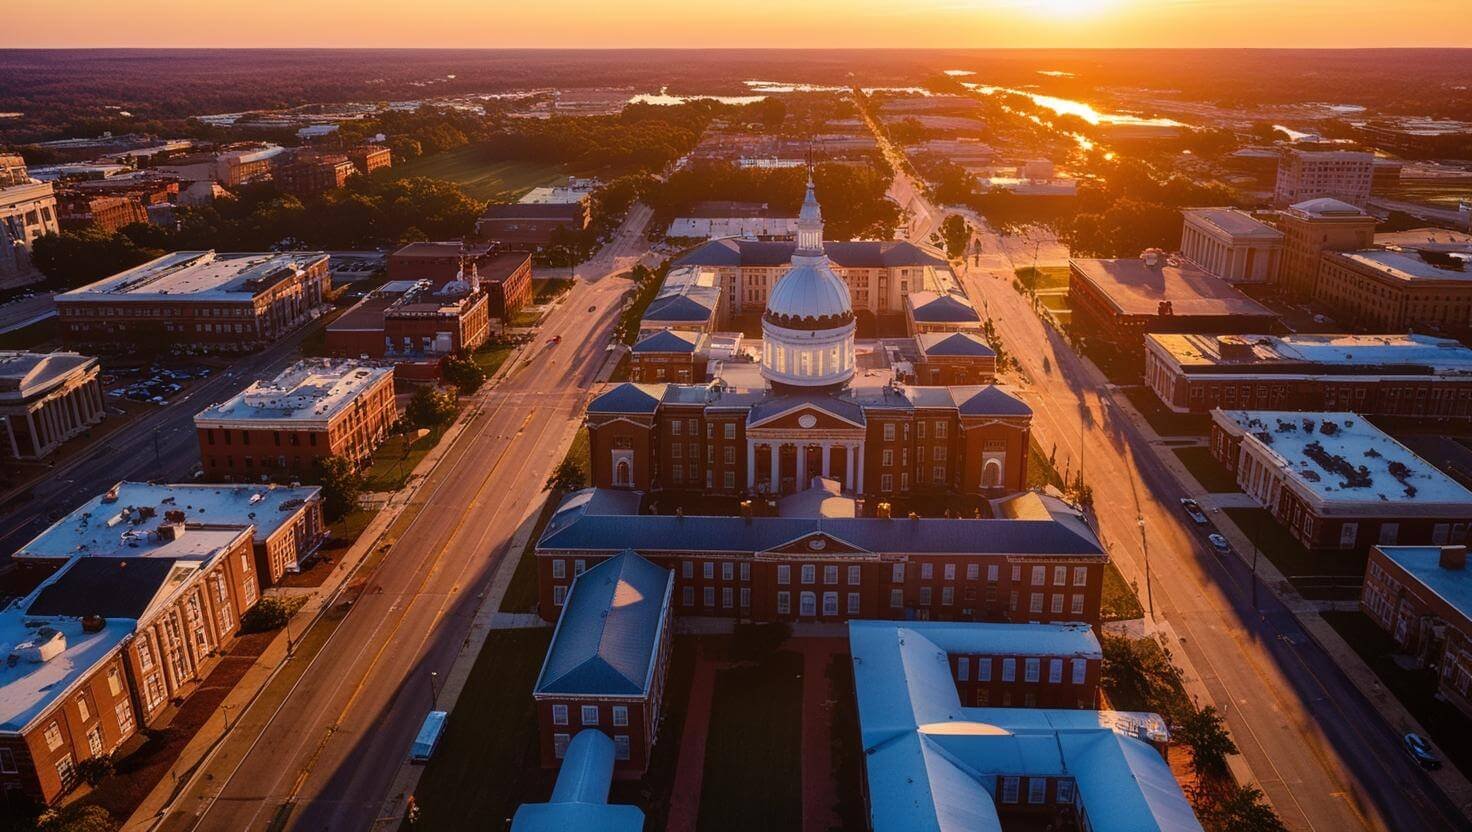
[0,0,1472,47]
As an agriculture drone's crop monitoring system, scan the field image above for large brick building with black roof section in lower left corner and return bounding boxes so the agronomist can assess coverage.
[0,517,259,803]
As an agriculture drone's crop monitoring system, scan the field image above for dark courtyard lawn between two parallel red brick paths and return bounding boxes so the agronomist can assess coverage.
[696,651,823,832]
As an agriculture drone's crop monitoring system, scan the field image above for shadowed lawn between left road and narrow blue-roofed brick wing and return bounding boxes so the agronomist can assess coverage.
[414,629,556,831]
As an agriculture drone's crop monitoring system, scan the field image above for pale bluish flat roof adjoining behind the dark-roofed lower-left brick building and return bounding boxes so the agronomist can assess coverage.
[16,482,322,558]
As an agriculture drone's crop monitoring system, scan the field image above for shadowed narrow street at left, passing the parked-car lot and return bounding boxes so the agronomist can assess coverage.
[0,321,332,560]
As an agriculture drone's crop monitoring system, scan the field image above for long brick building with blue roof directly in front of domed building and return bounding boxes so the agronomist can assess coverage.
[536,489,1108,624]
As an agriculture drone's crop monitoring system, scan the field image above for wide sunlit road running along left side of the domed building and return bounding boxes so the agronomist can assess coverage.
[153,206,649,831]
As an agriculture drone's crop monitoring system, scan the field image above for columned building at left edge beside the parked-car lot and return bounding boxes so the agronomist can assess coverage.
[0,350,107,459]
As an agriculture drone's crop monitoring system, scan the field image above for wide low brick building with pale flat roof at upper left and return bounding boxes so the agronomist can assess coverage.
[56,245,331,350]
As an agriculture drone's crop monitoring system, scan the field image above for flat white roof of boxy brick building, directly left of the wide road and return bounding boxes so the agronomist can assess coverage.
[194,358,393,427]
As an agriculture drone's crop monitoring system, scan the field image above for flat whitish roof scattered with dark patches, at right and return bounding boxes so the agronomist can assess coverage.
[1211,409,1472,503]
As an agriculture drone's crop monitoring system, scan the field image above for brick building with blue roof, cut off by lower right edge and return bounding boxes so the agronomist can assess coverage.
[1360,543,1472,717]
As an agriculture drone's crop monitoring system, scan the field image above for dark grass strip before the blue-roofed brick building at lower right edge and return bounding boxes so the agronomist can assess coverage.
[1320,613,1472,772]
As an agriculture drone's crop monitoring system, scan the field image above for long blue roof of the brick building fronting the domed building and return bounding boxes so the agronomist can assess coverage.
[537,514,1104,557]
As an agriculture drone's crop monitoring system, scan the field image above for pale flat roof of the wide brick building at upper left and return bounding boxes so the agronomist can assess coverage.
[56,252,327,302]
